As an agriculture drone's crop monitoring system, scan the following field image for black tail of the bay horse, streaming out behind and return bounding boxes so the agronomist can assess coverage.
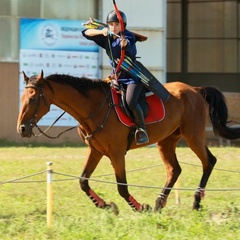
[199,87,240,139]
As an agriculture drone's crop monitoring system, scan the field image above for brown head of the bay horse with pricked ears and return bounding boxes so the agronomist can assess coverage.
[17,71,50,137]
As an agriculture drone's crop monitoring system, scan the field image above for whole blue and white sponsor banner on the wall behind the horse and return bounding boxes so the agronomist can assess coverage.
[19,18,100,126]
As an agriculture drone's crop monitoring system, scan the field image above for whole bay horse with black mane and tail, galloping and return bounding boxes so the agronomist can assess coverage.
[17,71,240,214]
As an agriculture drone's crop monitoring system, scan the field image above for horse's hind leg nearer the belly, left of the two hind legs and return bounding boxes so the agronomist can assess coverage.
[154,130,182,211]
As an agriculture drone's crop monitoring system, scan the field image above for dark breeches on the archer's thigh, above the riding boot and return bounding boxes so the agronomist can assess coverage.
[126,82,143,111]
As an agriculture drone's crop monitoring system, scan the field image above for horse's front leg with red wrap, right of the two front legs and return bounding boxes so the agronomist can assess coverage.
[111,154,151,212]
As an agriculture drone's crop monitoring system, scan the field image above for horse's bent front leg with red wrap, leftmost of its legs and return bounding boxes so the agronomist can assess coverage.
[79,147,118,214]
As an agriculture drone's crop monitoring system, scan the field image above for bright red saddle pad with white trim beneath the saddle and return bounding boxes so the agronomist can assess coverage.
[111,88,165,127]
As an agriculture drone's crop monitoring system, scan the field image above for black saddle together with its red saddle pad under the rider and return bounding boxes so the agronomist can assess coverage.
[111,83,165,127]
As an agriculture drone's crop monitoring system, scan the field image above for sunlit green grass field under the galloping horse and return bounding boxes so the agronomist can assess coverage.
[0,146,240,240]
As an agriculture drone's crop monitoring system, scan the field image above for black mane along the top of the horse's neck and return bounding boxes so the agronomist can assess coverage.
[45,74,107,94]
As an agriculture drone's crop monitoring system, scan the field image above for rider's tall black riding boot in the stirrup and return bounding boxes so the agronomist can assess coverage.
[132,105,149,145]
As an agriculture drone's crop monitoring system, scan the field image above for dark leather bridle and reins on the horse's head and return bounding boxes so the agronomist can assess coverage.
[25,85,77,139]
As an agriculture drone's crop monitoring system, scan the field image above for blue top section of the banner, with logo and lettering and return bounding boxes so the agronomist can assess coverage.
[20,18,99,52]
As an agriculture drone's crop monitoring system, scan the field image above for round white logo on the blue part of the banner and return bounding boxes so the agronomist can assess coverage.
[41,24,58,46]
